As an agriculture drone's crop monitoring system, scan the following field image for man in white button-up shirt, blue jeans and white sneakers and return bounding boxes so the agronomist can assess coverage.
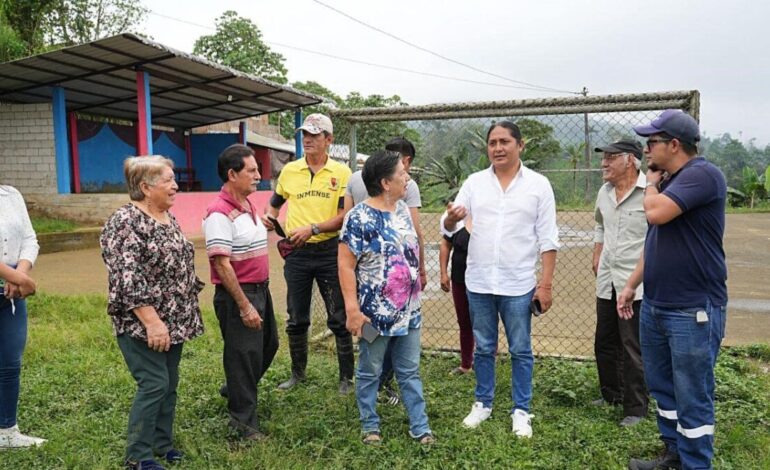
[441,121,559,437]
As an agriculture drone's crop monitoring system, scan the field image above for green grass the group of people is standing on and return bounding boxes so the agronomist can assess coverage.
[7,294,770,470]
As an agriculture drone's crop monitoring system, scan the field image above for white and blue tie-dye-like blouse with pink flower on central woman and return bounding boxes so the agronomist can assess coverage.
[340,201,422,336]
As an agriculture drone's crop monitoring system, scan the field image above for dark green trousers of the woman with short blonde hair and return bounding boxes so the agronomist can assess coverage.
[118,335,182,462]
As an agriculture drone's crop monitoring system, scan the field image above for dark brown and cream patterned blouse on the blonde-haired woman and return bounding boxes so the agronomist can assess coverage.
[99,204,203,344]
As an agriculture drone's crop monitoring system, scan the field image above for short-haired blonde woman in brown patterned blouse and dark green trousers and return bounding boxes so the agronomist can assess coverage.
[99,156,203,470]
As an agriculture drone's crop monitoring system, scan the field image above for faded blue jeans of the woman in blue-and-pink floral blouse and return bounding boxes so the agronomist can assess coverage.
[356,328,430,437]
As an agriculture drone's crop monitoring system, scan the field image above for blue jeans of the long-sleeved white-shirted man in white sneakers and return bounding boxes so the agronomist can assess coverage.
[468,289,535,412]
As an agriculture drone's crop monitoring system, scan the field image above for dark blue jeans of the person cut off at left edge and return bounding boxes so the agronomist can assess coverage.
[0,293,27,429]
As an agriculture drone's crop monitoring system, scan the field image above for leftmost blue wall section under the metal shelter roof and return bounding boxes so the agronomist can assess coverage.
[78,126,136,193]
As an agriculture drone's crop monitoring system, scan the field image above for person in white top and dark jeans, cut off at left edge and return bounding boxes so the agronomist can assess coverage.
[0,181,46,449]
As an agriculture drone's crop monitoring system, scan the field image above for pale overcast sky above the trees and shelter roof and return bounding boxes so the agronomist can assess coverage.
[143,0,770,146]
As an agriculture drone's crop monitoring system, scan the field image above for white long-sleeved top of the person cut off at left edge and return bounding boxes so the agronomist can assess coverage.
[0,185,40,266]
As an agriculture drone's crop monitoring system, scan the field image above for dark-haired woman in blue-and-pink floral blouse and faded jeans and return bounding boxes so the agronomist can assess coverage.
[338,151,435,445]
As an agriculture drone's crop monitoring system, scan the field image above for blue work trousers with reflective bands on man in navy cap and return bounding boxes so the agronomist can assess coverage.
[640,300,727,469]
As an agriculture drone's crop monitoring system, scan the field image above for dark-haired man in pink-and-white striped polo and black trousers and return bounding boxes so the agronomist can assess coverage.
[203,144,278,441]
